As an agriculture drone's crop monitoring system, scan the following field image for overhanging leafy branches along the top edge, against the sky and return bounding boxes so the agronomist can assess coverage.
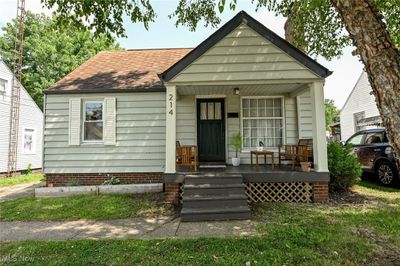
[42,0,400,60]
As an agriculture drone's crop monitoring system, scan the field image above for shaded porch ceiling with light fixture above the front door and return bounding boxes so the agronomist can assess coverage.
[177,83,304,96]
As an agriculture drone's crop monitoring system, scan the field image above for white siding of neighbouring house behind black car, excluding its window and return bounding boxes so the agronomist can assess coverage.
[340,72,379,140]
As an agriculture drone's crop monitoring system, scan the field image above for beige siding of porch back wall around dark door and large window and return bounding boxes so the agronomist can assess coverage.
[176,95,298,164]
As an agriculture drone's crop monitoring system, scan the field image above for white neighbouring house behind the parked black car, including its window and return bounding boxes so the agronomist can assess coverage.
[340,72,382,141]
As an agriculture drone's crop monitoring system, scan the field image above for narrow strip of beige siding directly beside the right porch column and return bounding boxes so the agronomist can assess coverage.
[297,89,313,139]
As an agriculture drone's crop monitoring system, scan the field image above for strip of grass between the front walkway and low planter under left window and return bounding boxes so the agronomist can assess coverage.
[0,193,172,221]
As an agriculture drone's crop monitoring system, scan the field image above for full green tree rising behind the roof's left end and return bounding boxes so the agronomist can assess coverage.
[0,12,119,108]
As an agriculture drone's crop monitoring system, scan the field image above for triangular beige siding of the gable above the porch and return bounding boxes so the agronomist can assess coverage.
[171,24,318,83]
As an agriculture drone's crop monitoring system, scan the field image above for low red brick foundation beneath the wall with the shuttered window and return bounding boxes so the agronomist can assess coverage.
[46,173,164,187]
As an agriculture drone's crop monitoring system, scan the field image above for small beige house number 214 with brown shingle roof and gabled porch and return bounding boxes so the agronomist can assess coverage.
[44,11,331,216]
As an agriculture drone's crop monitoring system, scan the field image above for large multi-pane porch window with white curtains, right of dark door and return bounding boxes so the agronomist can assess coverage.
[242,97,284,149]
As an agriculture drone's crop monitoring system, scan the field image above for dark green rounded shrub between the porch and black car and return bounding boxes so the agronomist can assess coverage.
[328,142,362,192]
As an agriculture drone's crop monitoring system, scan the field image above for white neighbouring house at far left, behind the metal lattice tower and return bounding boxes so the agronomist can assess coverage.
[0,60,43,174]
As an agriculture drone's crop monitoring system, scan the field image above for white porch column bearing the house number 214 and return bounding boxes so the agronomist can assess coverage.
[165,85,176,174]
